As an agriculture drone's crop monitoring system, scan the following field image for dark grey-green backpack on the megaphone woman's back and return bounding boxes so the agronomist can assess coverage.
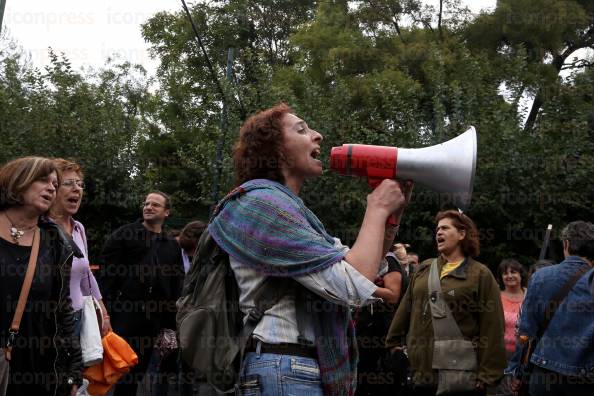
[176,229,280,393]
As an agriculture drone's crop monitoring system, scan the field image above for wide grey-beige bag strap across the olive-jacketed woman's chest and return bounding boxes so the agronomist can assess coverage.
[428,259,464,340]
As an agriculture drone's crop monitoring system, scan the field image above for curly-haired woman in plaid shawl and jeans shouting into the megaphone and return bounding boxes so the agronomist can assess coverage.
[208,104,411,396]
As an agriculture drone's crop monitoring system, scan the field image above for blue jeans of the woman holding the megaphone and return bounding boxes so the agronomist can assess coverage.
[237,352,324,396]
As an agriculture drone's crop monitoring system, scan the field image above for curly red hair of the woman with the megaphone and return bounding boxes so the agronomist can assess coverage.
[233,103,293,185]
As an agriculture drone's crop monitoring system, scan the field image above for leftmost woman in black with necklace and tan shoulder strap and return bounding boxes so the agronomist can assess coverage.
[0,157,82,396]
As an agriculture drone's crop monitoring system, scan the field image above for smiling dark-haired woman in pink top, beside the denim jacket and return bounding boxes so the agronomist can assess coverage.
[497,259,528,360]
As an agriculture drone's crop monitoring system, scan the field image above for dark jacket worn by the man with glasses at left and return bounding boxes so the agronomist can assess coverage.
[100,220,184,335]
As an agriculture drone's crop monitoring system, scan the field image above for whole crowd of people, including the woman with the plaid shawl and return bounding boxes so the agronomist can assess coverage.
[0,104,594,396]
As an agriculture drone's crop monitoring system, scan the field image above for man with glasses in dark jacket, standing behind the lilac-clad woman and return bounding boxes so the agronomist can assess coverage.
[101,191,184,396]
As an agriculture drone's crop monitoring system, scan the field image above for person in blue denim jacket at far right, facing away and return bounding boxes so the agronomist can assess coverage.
[506,221,594,396]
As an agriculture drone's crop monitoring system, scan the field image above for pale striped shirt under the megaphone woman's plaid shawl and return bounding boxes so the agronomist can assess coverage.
[229,238,377,344]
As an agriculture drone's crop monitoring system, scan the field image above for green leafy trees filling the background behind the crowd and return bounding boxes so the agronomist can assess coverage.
[0,0,594,268]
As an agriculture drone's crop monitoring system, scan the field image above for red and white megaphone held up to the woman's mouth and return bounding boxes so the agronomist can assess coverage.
[330,127,477,210]
